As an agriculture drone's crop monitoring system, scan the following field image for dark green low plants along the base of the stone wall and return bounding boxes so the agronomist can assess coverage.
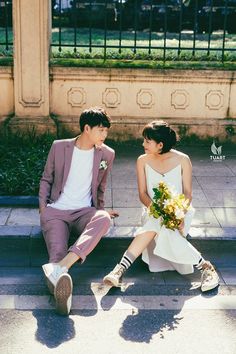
[0,131,235,196]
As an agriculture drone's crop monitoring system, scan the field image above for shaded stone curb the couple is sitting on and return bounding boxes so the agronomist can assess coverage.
[0,226,236,267]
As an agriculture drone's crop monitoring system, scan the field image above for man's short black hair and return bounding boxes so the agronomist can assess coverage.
[79,107,111,132]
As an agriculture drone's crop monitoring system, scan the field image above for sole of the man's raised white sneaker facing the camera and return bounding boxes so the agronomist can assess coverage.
[54,273,73,316]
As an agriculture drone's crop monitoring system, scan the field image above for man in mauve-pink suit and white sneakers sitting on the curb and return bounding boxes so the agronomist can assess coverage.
[39,107,118,315]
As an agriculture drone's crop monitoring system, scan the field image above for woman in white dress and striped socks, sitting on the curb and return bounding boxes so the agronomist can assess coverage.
[103,121,219,291]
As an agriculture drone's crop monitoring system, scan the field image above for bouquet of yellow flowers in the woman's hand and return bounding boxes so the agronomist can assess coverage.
[149,182,190,230]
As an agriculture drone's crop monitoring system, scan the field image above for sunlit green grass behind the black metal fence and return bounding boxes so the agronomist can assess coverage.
[0,28,236,70]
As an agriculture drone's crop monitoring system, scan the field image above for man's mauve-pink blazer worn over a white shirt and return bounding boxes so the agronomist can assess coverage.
[39,138,115,209]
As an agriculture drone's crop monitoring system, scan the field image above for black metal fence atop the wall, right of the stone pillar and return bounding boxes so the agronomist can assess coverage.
[52,0,236,61]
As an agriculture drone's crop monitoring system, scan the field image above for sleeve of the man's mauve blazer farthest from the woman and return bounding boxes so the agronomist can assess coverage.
[39,143,55,208]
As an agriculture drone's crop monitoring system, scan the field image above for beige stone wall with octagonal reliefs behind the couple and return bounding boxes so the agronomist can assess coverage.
[0,67,236,141]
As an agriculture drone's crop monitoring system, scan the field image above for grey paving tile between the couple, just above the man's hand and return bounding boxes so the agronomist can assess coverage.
[112,189,141,208]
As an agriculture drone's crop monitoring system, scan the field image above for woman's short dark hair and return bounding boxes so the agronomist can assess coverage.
[142,120,179,154]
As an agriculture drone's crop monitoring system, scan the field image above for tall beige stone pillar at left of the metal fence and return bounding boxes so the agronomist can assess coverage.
[11,0,54,131]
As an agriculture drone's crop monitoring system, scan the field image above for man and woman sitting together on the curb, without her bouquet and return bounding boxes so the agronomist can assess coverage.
[39,108,219,315]
